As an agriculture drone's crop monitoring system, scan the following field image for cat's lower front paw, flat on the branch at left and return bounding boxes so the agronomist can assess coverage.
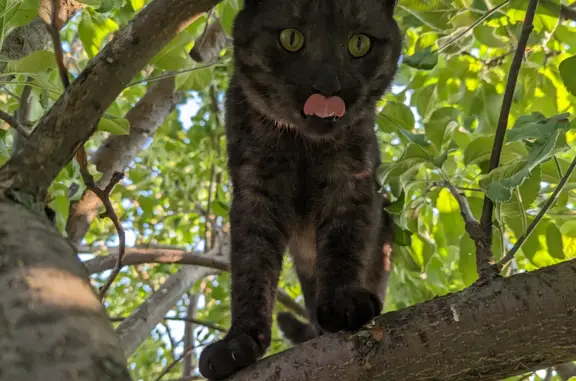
[199,334,265,380]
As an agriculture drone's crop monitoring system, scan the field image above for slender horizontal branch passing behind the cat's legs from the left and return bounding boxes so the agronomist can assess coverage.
[84,243,308,321]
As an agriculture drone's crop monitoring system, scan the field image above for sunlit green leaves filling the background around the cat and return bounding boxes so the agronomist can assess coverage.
[0,0,576,380]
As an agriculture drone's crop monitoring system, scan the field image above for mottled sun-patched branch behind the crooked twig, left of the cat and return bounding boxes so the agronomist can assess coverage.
[66,77,181,244]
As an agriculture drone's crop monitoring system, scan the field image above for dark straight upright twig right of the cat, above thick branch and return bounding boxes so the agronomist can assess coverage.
[476,0,538,275]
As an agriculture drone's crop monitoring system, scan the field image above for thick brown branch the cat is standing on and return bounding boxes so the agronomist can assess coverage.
[229,259,576,381]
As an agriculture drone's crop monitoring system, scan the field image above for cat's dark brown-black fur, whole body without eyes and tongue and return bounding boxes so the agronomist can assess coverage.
[200,0,401,380]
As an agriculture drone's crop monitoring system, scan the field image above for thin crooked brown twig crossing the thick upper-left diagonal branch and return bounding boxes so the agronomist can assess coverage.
[49,0,126,299]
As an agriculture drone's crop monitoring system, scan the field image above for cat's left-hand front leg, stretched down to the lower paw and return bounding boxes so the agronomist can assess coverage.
[199,191,289,380]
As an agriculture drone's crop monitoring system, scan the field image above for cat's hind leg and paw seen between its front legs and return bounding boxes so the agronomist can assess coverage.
[276,270,321,345]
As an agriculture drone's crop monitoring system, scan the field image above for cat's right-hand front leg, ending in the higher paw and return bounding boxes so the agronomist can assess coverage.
[316,187,382,332]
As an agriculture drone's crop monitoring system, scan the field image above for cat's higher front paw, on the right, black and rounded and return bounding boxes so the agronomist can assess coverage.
[316,287,382,332]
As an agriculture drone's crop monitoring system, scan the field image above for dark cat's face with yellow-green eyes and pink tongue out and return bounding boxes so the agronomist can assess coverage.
[234,0,401,139]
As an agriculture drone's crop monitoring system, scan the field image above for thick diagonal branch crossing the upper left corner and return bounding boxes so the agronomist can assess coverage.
[0,0,218,201]
